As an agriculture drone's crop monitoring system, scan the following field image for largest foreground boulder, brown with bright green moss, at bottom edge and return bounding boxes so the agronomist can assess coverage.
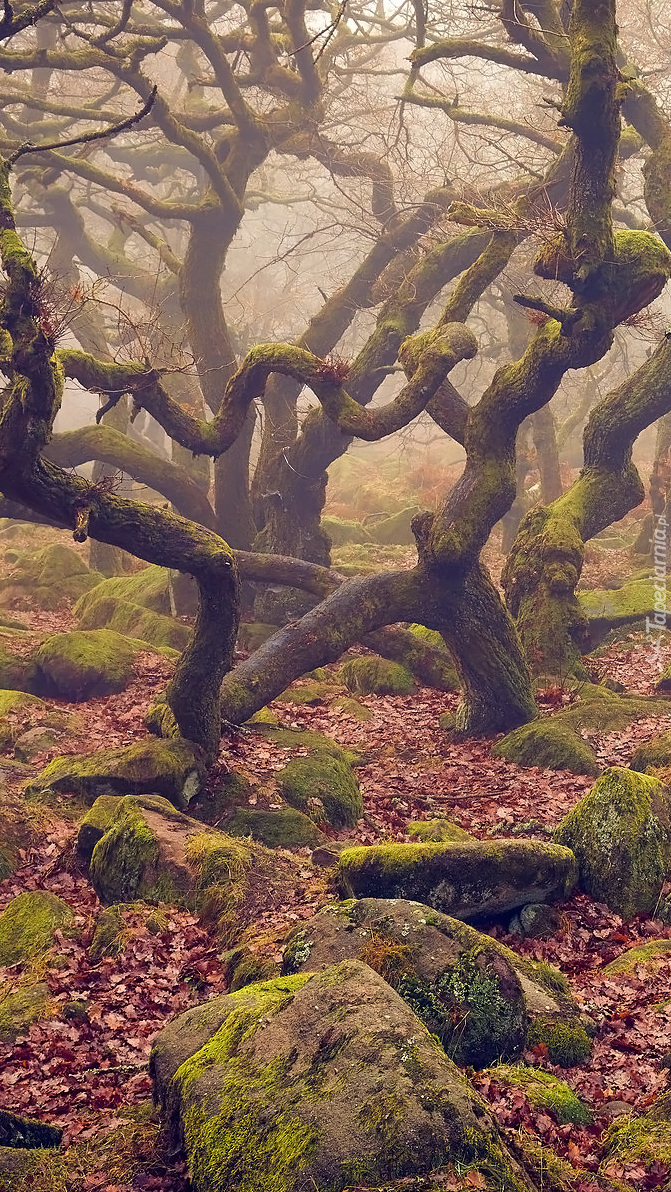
[151,961,530,1192]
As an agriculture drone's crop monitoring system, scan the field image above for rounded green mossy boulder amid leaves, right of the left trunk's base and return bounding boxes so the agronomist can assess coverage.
[275,753,364,827]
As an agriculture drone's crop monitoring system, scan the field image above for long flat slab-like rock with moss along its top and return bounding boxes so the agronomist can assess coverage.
[337,840,577,919]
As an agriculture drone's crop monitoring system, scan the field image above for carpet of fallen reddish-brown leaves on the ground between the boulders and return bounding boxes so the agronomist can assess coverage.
[0,522,671,1192]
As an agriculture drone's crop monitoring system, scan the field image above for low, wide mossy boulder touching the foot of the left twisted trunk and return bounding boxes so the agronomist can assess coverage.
[26,737,205,807]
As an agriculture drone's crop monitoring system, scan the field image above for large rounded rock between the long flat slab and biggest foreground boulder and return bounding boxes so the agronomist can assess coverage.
[282,899,580,1068]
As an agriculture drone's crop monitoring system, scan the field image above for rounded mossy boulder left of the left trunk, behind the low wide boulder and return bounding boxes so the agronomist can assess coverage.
[35,629,168,701]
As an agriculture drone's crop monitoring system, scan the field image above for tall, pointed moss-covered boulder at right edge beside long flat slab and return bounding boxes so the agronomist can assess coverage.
[553,766,671,919]
